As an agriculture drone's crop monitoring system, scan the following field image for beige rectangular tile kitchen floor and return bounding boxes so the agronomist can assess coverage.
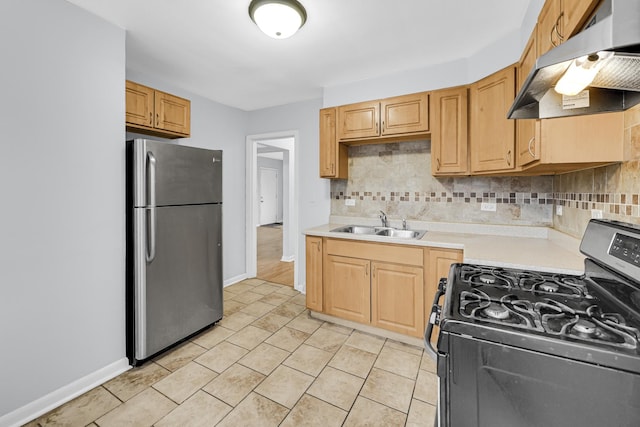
[27,279,437,427]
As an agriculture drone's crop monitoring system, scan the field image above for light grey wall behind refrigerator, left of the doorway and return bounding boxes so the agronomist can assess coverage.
[127,69,249,283]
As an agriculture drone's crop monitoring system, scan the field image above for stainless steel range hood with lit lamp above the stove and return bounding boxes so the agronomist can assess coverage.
[507,0,640,119]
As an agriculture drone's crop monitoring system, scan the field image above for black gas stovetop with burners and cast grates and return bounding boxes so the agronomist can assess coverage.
[450,264,640,352]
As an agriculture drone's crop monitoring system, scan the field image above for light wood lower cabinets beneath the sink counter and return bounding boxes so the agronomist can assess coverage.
[306,236,462,337]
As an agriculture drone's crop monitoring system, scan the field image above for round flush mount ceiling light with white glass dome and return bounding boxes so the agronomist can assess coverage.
[249,0,307,39]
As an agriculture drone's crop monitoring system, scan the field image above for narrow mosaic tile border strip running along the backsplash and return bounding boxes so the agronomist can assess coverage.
[331,191,640,217]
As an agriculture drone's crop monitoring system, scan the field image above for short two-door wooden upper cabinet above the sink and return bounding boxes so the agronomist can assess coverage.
[338,92,429,142]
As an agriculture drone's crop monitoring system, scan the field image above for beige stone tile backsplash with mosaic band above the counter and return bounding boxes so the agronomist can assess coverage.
[331,139,640,237]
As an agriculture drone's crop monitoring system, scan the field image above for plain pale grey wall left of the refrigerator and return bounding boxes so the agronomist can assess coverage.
[0,0,126,425]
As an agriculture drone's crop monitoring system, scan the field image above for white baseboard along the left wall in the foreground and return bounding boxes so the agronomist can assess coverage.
[0,357,131,427]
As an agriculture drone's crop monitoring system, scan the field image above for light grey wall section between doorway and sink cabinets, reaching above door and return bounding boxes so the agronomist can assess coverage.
[247,99,331,286]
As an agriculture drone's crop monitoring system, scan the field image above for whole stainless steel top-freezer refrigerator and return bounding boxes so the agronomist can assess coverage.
[126,139,222,365]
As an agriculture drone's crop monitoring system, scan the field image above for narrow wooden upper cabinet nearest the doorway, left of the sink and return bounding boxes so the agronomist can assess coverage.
[320,107,348,179]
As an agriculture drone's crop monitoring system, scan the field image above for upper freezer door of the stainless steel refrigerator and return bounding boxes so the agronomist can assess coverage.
[133,139,222,207]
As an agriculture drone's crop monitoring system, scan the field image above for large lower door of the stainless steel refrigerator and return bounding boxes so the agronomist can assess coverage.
[133,204,222,361]
